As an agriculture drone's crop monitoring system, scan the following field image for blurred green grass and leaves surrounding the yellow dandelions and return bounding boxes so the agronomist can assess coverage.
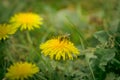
[0,0,120,80]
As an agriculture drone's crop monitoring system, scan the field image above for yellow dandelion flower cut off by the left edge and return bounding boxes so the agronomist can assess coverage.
[0,24,17,40]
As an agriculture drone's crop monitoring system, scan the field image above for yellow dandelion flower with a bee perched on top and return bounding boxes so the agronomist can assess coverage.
[40,37,79,60]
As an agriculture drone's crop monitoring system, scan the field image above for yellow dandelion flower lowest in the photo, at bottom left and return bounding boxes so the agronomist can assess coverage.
[5,62,39,80]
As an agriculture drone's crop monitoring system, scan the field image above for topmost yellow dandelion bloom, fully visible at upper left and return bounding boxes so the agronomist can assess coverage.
[10,13,43,30]
